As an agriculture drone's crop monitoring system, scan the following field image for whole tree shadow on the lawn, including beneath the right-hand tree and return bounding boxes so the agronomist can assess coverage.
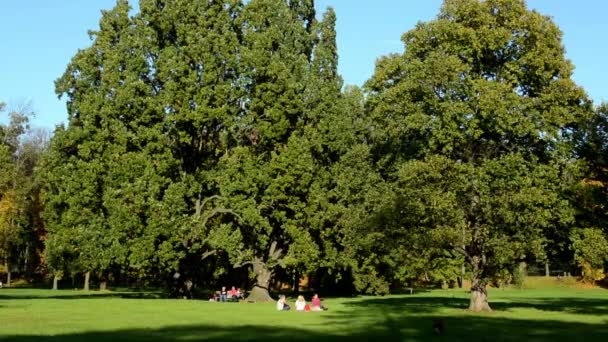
[0,296,608,342]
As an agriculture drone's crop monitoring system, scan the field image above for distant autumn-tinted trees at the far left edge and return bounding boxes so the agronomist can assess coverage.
[0,102,49,286]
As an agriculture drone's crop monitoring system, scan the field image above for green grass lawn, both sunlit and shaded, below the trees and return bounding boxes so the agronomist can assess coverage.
[0,288,608,342]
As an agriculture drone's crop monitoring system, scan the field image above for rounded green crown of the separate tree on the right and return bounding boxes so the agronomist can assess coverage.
[366,0,590,308]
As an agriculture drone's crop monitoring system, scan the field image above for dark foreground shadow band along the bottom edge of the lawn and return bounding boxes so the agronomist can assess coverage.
[2,315,608,342]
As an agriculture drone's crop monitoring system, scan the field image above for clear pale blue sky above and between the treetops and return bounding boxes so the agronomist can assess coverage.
[0,0,608,128]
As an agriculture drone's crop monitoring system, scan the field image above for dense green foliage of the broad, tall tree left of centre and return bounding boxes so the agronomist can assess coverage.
[45,0,348,296]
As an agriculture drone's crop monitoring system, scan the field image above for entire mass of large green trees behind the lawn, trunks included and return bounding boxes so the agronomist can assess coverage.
[3,0,608,310]
